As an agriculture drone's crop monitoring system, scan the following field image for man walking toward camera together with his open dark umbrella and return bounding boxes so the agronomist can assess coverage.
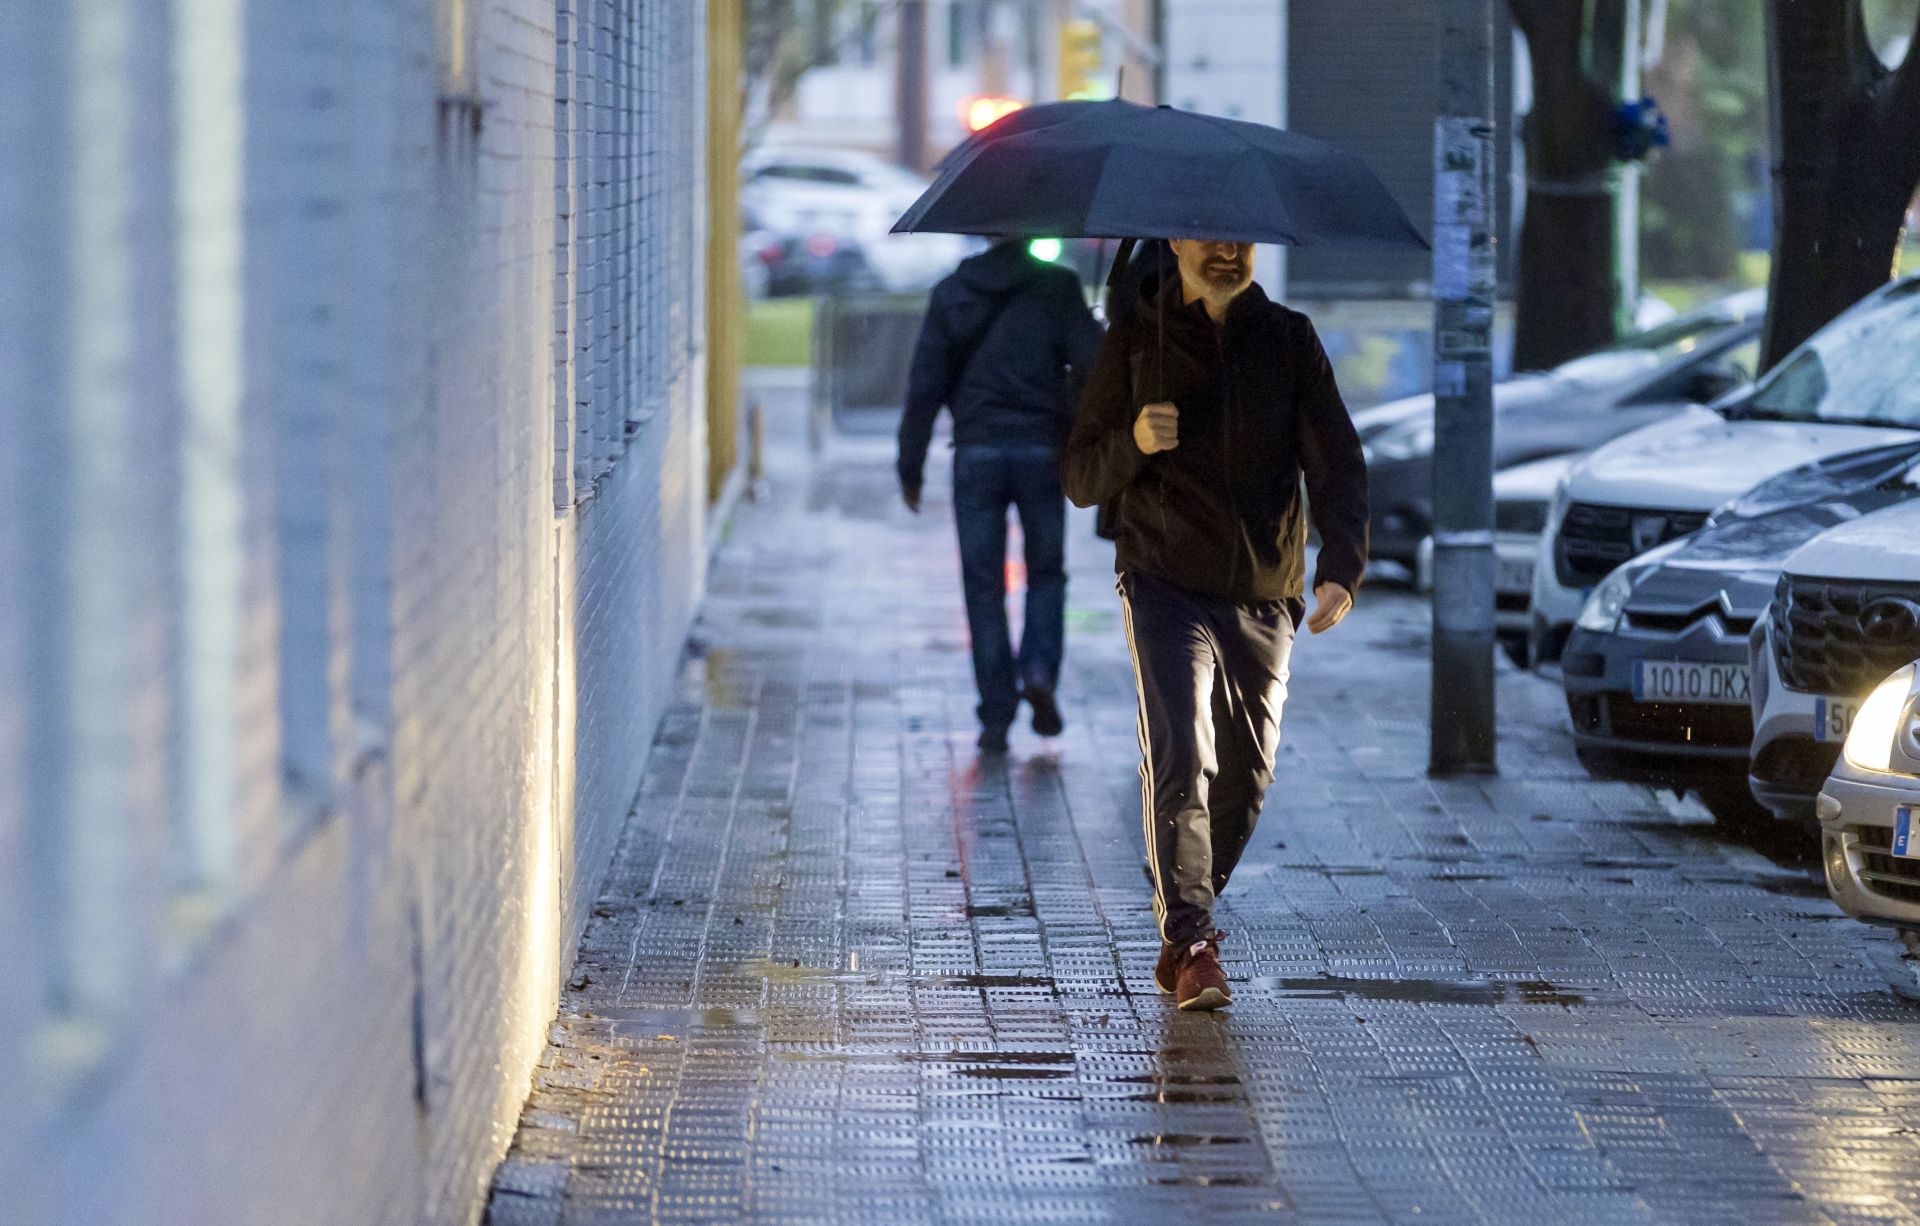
[895,100,1427,1009]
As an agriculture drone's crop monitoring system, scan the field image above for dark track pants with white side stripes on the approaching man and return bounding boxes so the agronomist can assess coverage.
[1119,572,1302,944]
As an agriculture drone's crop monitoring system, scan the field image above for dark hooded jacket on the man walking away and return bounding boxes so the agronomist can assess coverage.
[900,242,1100,489]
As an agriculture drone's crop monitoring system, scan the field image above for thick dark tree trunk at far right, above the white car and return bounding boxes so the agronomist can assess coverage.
[1761,0,1920,366]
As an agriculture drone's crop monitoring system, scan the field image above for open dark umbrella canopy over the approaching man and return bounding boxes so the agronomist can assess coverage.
[893,100,1427,248]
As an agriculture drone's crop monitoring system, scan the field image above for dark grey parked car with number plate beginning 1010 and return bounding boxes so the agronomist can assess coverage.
[1561,437,1920,825]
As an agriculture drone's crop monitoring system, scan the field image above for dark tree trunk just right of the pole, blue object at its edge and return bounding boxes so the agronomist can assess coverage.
[1507,0,1620,370]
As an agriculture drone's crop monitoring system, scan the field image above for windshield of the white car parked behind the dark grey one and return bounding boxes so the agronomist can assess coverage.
[1736,278,1920,430]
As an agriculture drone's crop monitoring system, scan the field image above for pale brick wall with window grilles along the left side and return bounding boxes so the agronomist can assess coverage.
[0,0,707,1226]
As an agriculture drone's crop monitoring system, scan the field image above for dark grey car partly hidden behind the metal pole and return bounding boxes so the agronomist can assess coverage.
[1354,290,1766,566]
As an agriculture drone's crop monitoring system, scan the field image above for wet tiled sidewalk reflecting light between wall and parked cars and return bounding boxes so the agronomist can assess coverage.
[490,376,1920,1226]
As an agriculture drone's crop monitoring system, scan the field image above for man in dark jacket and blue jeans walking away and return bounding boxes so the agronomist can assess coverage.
[899,238,1102,752]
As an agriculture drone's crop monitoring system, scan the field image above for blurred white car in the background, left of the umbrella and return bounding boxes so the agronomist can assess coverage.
[739,146,979,294]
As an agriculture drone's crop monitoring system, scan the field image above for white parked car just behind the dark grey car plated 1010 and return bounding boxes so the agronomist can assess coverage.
[1528,276,1920,662]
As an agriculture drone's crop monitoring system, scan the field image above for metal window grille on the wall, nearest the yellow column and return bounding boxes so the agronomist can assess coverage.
[553,0,701,510]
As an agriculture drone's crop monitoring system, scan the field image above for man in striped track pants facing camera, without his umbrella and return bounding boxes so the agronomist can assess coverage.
[1062,240,1367,1009]
